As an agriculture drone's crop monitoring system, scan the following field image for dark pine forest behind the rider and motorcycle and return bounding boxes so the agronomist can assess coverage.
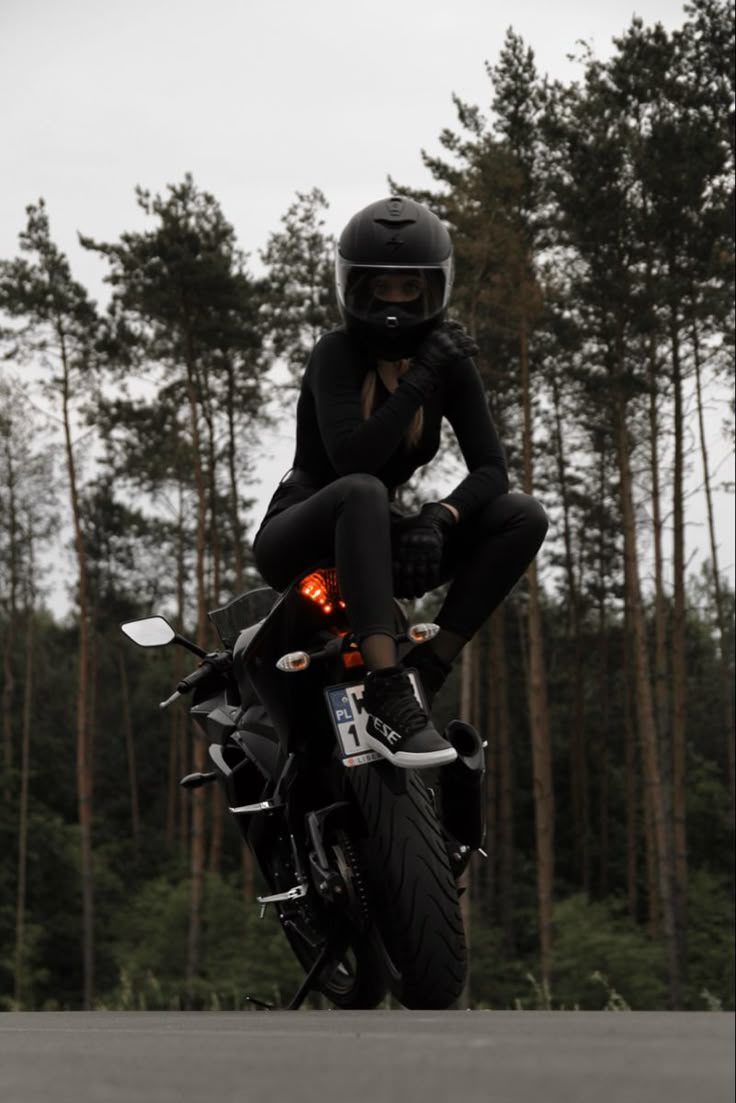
[0,0,735,1010]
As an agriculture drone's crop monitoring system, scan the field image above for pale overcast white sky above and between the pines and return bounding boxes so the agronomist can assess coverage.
[0,0,734,595]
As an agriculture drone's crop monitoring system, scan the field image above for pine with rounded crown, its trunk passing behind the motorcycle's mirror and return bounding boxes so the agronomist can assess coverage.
[82,176,268,1005]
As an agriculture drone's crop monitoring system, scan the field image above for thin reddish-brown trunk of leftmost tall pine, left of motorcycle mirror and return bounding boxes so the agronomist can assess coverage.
[58,326,95,1010]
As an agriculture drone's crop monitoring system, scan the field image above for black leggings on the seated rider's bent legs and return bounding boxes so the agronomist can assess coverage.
[254,474,547,641]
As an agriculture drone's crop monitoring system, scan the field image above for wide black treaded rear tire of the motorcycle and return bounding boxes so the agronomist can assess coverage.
[350,763,467,1010]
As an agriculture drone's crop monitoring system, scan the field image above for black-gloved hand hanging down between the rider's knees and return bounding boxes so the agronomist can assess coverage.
[393,502,456,598]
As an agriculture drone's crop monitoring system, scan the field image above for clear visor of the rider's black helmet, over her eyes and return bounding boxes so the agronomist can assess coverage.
[335,256,452,322]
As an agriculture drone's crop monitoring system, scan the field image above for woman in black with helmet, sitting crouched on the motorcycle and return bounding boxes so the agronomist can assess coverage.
[254,196,547,768]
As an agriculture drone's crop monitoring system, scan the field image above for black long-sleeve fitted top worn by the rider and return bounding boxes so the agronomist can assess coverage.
[258,330,509,522]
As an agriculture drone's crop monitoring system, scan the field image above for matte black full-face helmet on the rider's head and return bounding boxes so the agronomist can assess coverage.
[335,195,454,360]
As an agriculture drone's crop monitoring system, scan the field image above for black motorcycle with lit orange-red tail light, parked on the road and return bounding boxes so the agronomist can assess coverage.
[121,567,484,1008]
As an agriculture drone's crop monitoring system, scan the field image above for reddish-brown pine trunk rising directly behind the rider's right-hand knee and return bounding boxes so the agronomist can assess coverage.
[520,321,554,989]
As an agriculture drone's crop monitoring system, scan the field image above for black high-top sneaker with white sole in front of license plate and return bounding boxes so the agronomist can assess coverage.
[363,666,458,770]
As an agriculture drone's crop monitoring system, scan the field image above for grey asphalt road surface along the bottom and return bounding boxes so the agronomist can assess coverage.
[0,1011,734,1103]
